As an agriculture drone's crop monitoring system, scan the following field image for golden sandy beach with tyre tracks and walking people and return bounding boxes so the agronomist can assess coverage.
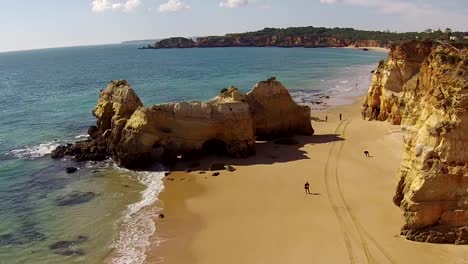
[147,98,468,264]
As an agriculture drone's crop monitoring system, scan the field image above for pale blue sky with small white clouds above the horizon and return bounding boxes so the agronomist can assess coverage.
[0,0,468,51]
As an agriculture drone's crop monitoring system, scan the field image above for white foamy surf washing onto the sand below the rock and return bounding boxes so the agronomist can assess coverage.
[111,169,164,264]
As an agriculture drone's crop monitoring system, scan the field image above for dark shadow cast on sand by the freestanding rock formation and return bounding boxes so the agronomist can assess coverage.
[173,134,344,171]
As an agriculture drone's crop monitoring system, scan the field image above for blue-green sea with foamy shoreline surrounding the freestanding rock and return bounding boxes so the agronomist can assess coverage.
[0,44,387,264]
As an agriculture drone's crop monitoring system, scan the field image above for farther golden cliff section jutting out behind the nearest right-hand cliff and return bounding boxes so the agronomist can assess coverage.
[362,42,432,125]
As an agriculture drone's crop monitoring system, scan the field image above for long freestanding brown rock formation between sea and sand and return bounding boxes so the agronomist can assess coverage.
[52,78,313,168]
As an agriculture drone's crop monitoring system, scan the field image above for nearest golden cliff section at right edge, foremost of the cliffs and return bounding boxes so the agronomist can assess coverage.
[394,46,468,244]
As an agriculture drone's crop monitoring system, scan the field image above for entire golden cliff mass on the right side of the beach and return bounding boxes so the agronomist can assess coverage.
[363,42,468,244]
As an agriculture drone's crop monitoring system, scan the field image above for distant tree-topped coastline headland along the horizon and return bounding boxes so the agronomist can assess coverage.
[137,27,468,49]
